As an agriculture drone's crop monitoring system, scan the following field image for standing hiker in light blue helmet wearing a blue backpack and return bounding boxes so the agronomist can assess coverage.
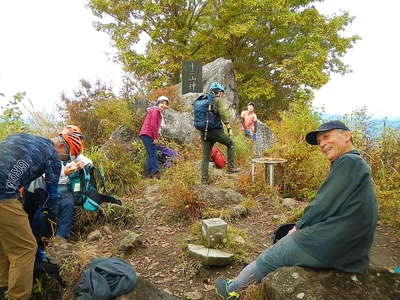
[193,82,240,184]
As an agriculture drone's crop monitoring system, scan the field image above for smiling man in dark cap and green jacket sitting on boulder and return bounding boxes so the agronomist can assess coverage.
[216,121,378,299]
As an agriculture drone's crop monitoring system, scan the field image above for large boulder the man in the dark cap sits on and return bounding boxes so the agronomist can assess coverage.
[252,267,400,300]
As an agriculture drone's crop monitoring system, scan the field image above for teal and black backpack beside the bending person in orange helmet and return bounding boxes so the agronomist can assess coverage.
[68,164,122,211]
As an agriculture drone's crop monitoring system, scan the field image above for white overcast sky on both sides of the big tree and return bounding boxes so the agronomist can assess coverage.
[0,0,400,119]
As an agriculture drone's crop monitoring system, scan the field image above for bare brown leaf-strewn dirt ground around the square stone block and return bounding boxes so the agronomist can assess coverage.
[49,166,400,299]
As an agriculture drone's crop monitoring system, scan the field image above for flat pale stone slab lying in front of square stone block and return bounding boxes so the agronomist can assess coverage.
[188,244,233,266]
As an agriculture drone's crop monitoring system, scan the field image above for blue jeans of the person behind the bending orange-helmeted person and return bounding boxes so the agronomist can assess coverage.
[55,185,75,239]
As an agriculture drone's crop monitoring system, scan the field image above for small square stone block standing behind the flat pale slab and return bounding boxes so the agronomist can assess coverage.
[201,218,228,248]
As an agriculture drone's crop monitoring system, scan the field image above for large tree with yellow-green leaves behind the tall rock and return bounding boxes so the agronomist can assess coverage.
[89,0,358,117]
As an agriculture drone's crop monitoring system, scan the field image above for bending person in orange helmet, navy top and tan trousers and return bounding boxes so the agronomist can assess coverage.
[0,133,82,300]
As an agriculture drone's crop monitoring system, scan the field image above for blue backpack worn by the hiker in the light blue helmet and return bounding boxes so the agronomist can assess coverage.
[192,94,222,131]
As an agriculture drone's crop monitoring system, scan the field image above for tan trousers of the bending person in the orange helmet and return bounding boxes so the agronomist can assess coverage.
[0,199,37,300]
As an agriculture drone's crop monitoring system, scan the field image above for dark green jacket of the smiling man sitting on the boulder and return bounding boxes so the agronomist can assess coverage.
[292,150,378,273]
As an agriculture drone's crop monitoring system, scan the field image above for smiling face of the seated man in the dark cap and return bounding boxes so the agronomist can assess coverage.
[317,129,352,161]
